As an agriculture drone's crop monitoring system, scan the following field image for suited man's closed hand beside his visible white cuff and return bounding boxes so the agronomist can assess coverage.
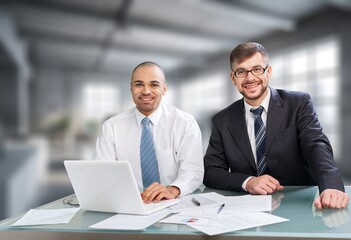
[246,175,284,195]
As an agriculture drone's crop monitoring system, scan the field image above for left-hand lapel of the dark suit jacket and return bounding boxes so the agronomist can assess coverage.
[228,99,256,171]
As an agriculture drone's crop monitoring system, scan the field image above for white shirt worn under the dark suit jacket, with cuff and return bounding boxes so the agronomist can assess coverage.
[242,90,271,191]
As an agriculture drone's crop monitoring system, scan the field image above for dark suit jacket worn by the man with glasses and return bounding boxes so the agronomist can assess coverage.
[204,88,344,192]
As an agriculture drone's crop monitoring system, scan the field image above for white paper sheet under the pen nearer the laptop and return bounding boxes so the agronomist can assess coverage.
[169,192,225,213]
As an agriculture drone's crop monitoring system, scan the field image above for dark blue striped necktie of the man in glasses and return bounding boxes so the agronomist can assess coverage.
[250,106,267,176]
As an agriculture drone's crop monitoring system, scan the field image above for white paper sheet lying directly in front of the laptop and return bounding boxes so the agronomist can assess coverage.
[90,209,170,230]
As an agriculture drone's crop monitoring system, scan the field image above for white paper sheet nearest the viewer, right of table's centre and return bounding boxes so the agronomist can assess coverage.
[187,212,289,235]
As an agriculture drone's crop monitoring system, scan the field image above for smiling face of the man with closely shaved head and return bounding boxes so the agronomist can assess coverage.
[131,64,167,116]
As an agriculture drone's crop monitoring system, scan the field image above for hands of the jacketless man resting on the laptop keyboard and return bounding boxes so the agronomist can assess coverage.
[141,182,180,203]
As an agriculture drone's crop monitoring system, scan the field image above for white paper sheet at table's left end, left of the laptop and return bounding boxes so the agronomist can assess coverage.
[12,208,79,227]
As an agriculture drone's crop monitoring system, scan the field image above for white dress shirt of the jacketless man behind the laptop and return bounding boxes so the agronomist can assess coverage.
[93,104,204,196]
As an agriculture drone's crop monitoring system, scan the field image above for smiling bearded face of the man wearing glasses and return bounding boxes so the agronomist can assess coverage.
[230,53,272,106]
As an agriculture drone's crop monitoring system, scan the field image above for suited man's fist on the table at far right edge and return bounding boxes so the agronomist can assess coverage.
[314,189,349,209]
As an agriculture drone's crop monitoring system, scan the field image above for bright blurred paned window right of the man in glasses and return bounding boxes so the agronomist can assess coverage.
[270,38,340,159]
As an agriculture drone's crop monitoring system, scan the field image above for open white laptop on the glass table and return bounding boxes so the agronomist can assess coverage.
[64,160,179,215]
